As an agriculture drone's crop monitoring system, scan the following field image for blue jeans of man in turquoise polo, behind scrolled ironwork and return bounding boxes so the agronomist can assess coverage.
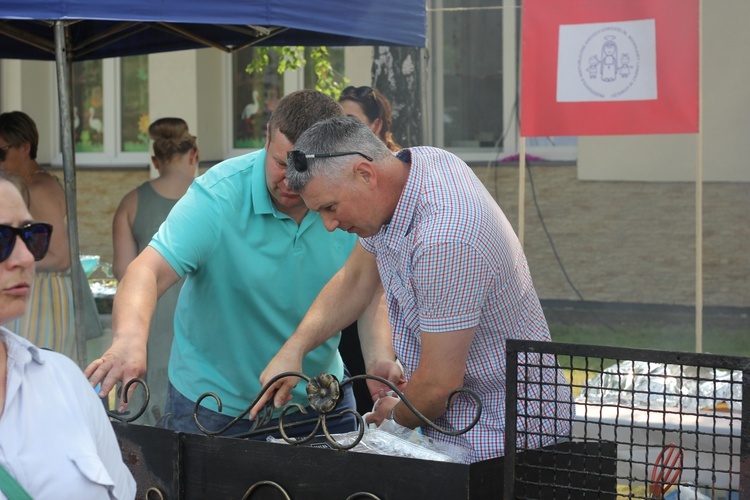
[156,373,357,441]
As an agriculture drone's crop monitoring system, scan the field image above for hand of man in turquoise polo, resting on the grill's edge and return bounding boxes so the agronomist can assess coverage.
[83,338,146,412]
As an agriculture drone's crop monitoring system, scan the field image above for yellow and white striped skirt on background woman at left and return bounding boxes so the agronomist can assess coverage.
[5,270,78,363]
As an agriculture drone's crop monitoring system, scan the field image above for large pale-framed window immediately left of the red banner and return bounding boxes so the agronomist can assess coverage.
[427,0,578,161]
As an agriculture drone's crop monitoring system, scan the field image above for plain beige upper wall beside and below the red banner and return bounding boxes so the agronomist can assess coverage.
[578,0,750,182]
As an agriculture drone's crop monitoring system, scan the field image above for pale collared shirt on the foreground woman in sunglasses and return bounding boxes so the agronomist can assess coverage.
[0,327,136,499]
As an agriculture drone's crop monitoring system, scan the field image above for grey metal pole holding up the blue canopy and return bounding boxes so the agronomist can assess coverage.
[55,21,88,368]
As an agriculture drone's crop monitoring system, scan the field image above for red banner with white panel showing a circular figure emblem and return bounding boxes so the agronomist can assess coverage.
[521,0,700,137]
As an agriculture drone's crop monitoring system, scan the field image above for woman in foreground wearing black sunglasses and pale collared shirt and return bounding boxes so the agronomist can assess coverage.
[0,172,136,499]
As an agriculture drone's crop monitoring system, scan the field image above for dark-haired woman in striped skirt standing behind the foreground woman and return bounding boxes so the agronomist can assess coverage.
[0,111,98,362]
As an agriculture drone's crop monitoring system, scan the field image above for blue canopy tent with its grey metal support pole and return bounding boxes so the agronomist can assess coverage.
[0,0,427,366]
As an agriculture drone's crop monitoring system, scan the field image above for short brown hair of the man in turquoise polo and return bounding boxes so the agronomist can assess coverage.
[268,90,344,144]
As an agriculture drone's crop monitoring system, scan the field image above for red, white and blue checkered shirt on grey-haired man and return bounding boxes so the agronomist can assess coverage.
[360,147,571,462]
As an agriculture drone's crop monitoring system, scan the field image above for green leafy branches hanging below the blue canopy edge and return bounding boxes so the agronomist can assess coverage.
[245,47,349,99]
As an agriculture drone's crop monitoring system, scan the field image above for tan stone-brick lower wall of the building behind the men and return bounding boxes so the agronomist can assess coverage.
[67,166,750,307]
